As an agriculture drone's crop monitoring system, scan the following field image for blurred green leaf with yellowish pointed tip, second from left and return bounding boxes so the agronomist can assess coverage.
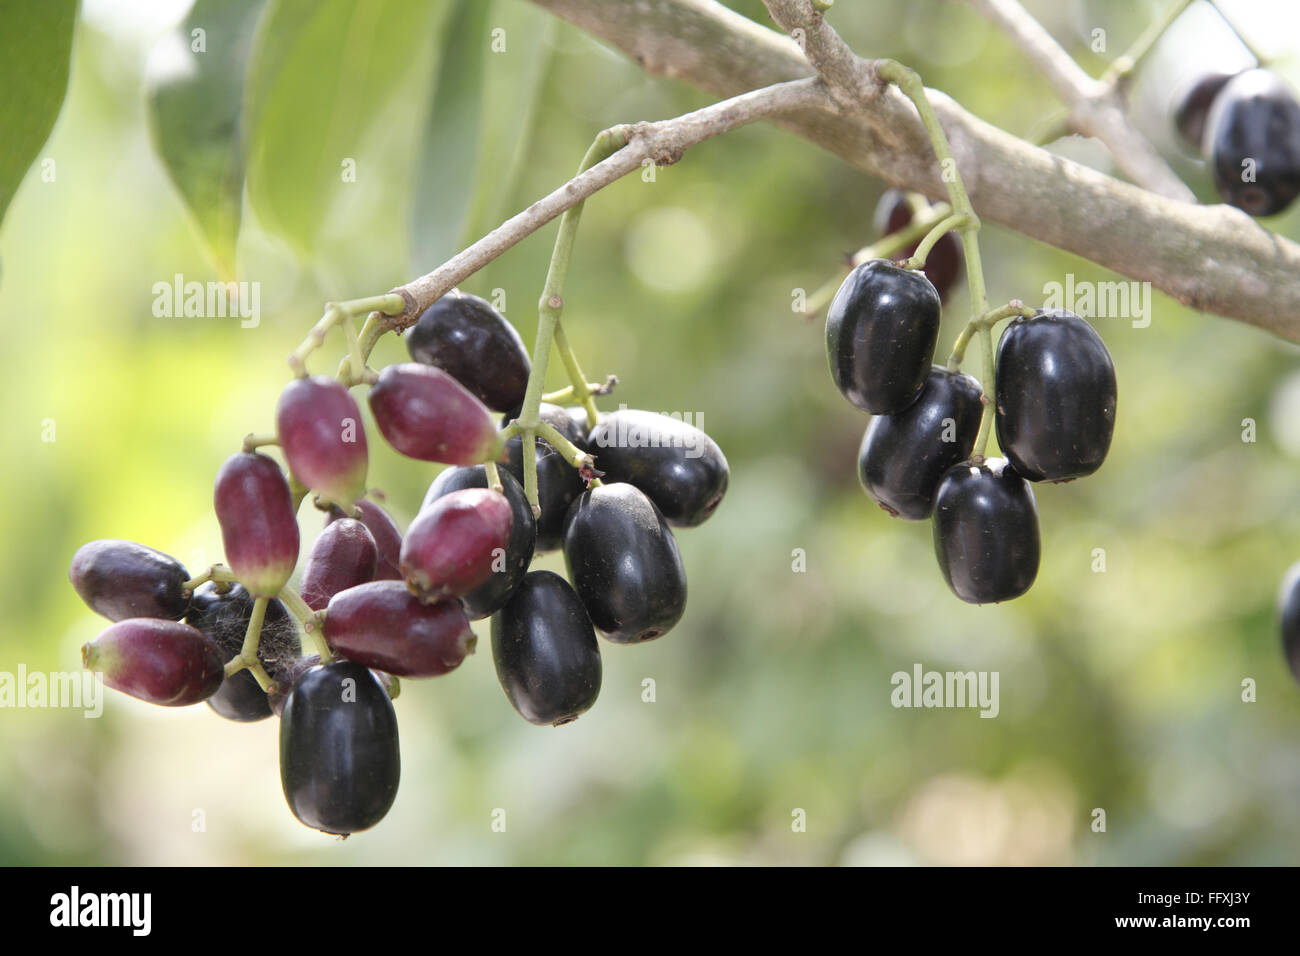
[148,0,264,280]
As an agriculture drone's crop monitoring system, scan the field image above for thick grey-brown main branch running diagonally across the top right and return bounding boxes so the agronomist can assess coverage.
[522,0,1300,341]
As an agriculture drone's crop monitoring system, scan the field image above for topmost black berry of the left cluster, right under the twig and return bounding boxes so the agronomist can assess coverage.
[406,290,532,411]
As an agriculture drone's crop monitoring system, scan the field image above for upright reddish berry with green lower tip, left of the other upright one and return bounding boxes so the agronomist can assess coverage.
[213,451,298,597]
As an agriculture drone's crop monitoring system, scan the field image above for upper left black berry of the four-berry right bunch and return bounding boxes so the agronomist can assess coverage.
[826,259,940,415]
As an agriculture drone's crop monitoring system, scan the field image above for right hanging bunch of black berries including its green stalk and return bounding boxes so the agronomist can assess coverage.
[814,61,1117,604]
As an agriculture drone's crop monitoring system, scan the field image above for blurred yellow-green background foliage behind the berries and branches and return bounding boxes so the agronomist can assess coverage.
[0,0,1300,865]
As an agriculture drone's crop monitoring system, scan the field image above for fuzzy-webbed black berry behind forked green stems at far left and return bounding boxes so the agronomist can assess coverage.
[186,581,302,721]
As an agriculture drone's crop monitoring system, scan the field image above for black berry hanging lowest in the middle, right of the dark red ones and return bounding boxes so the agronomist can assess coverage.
[491,571,601,727]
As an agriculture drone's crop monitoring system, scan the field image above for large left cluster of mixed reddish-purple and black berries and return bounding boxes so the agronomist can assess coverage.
[69,293,729,834]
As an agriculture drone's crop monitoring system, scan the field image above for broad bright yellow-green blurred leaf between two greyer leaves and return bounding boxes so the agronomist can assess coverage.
[244,0,441,255]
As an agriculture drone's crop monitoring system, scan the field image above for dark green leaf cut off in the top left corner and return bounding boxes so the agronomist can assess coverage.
[0,0,77,231]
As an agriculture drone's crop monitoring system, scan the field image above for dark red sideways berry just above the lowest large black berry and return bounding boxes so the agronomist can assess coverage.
[324,581,477,678]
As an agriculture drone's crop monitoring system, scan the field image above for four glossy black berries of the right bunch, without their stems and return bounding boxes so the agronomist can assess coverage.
[826,259,1115,604]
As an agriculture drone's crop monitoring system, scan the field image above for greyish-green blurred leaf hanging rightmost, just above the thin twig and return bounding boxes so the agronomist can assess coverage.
[411,0,555,272]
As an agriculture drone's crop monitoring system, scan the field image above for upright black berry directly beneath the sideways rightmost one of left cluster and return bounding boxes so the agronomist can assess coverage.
[564,483,686,644]
